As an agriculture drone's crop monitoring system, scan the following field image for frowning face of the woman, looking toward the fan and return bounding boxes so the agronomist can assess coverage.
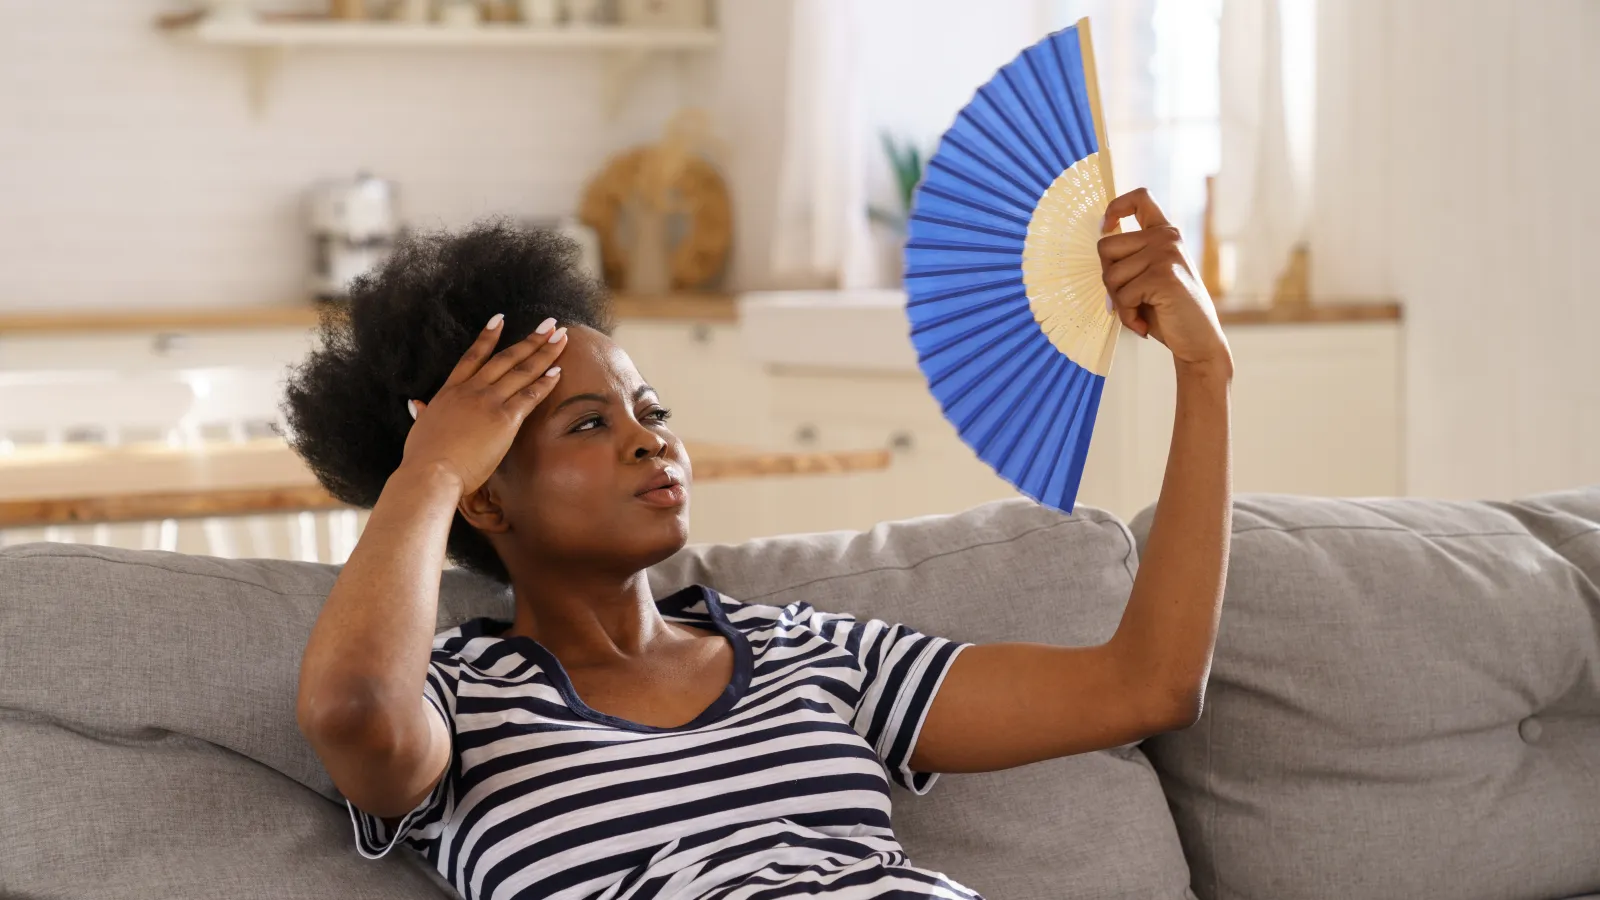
[485,325,691,575]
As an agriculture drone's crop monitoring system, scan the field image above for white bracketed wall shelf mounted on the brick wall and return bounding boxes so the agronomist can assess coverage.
[160,16,720,115]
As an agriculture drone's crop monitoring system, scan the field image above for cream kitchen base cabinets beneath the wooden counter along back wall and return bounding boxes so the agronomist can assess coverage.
[0,304,1406,541]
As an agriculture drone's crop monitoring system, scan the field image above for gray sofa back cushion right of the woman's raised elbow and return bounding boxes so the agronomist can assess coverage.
[1133,488,1600,900]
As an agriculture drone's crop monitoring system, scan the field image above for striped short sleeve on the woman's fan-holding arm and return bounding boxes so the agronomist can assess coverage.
[810,610,970,794]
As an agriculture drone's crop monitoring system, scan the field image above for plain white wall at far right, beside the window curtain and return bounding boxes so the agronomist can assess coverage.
[1312,0,1600,498]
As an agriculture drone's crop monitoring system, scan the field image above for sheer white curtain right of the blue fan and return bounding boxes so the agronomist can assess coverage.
[1216,0,1315,301]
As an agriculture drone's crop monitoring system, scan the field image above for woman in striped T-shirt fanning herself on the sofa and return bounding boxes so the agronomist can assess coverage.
[288,184,1232,900]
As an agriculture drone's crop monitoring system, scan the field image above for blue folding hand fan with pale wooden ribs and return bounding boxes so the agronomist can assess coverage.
[906,19,1122,512]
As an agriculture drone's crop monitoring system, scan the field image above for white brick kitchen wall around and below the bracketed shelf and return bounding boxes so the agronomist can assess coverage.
[0,0,787,309]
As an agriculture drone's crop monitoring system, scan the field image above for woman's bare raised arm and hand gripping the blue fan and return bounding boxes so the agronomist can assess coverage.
[912,189,1234,772]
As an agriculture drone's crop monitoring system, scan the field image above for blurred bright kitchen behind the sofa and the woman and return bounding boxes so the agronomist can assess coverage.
[0,0,1600,562]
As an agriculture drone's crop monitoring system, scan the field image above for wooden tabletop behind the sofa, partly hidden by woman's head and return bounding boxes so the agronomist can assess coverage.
[0,437,891,528]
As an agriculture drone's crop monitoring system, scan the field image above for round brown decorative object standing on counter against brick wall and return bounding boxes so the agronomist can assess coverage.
[578,110,733,290]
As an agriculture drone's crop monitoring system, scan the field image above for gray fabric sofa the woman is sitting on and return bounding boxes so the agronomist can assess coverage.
[0,487,1600,900]
